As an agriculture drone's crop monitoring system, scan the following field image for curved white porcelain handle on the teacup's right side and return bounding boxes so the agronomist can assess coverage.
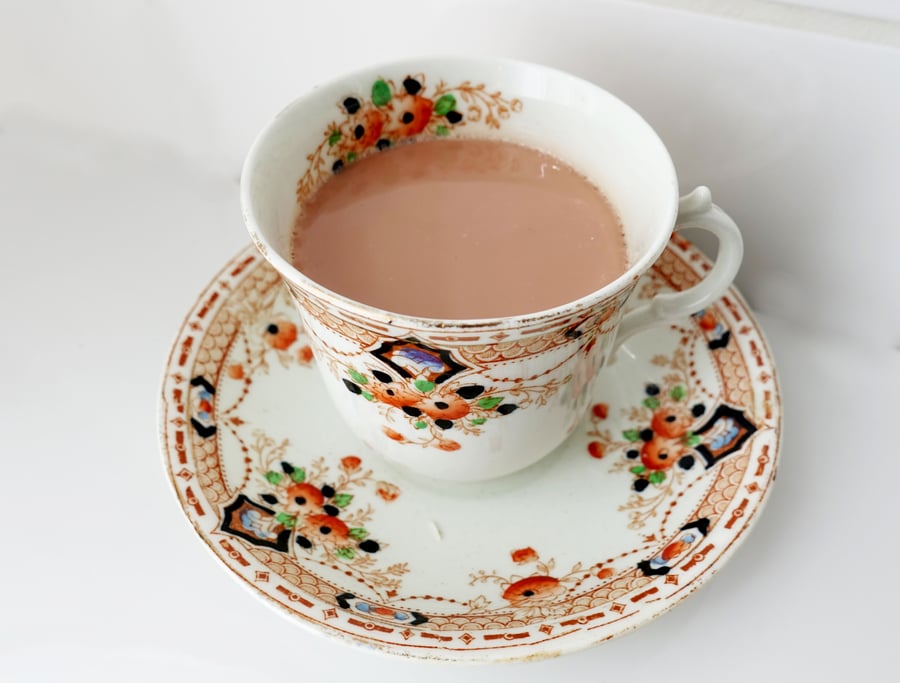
[613,186,744,354]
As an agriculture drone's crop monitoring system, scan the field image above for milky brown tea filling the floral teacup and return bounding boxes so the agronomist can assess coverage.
[293,139,627,320]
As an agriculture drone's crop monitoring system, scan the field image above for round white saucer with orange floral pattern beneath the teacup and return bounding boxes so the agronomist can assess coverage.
[159,235,781,662]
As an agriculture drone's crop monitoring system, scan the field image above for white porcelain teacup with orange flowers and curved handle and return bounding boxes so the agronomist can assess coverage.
[241,58,743,481]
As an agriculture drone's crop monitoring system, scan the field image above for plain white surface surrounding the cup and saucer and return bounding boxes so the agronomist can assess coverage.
[0,0,900,682]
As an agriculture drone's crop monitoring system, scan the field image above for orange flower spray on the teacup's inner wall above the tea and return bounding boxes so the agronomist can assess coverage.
[297,74,522,202]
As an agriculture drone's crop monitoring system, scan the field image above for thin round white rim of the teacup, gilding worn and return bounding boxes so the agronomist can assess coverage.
[240,55,679,332]
